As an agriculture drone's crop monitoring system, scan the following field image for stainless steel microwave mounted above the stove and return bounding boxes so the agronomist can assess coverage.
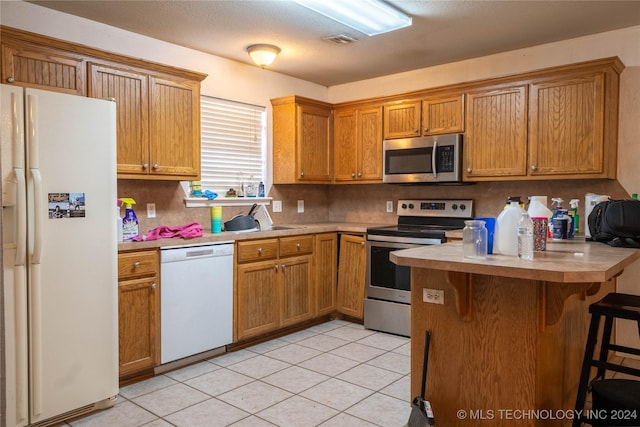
[382,133,462,184]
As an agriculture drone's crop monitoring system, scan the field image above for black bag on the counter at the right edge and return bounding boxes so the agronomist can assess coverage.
[588,199,640,248]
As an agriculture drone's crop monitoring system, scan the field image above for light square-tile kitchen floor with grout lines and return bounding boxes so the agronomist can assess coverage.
[65,320,411,427]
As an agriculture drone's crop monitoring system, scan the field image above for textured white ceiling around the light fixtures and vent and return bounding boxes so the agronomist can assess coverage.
[30,0,640,86]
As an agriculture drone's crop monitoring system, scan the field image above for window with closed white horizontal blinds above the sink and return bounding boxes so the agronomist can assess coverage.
[200,95,266,197]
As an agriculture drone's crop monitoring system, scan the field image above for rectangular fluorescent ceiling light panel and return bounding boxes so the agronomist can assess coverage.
[294,0,411,36]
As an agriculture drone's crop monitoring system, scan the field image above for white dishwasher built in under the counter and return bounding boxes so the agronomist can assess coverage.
[160,242,233,363]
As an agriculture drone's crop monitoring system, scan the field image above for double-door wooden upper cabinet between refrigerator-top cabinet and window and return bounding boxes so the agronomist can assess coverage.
[89,62,200,180]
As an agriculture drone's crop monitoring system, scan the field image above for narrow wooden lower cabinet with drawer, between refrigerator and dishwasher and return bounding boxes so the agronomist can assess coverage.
[118,250,160,378]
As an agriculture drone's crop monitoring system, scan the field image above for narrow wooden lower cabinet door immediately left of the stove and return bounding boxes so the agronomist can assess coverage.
[337,234,367,319]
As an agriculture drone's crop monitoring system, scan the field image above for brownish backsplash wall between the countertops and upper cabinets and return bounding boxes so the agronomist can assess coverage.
[118,180,629,233]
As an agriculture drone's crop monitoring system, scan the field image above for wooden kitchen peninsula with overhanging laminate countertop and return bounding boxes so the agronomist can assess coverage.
[391,241,640,426]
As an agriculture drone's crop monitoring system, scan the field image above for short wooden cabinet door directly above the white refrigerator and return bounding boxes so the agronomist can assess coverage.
[2,39,86,95]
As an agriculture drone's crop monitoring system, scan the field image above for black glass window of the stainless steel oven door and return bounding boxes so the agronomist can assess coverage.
[369,244,411,291]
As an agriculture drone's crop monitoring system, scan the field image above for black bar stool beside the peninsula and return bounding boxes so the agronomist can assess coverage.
[573,293,640,427]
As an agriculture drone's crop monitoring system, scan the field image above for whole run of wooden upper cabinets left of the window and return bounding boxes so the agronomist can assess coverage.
[0,26,206,180]
